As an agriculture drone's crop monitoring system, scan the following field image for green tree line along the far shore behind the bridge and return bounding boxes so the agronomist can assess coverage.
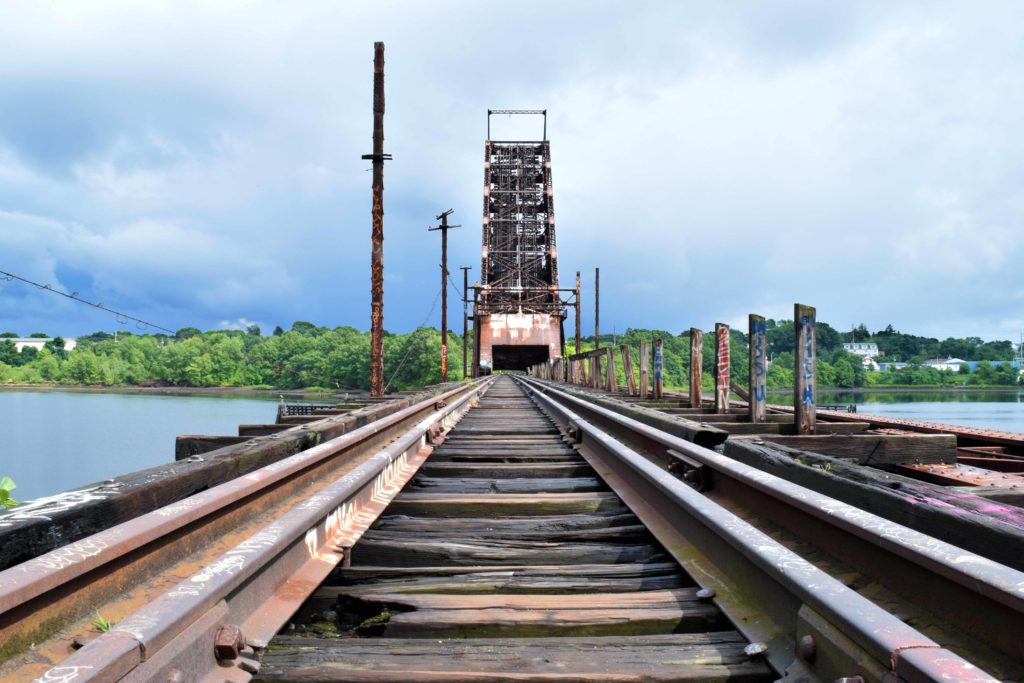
[0,319,1017,390]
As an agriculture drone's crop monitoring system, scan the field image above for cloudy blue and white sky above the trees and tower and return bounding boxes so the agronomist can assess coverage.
[0,0,1024,341]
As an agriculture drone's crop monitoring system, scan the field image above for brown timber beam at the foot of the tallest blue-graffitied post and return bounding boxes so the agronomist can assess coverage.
[753,436,956,465]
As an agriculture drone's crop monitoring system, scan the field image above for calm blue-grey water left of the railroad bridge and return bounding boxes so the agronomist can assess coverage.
[0,391,278,502]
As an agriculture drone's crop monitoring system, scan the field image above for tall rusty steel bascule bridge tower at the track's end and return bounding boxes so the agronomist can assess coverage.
[473,110,566,375]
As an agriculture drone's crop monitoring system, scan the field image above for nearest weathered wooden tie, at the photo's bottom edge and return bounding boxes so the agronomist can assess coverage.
[256,631,774,683]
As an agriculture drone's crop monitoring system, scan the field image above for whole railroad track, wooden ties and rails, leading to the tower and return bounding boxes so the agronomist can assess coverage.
[0,376,1024,683]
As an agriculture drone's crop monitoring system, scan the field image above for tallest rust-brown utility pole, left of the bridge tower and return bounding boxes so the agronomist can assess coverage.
[362,42,391,396]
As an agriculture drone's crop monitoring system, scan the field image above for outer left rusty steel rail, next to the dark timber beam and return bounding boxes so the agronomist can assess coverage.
[0,383,480,679]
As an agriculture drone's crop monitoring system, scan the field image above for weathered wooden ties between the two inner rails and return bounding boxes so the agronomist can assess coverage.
[260,377,772,681]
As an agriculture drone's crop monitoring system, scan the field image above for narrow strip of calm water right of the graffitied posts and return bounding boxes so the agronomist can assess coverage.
[818,391,1024,432]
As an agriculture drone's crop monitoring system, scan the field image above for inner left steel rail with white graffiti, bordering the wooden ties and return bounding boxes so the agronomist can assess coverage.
[29,380,493,683]
